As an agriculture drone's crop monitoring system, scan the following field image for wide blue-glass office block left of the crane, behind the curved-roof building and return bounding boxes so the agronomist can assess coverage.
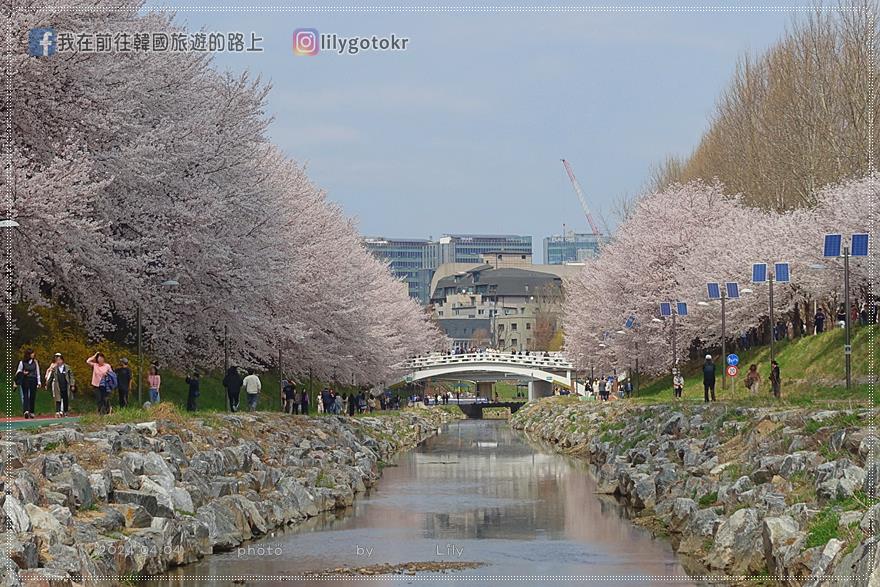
[363,234,532,305]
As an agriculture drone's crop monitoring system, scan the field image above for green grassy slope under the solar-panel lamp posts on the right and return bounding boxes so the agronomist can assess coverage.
[636,325,880,406]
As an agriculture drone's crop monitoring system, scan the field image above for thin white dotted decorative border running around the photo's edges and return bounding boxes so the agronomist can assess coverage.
[0,5,880,582]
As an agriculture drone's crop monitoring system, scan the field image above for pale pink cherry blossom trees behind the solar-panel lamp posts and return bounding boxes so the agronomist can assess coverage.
[564,175,880,372]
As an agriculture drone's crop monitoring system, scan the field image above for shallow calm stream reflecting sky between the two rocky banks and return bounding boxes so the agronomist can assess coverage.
[161,420,689,585]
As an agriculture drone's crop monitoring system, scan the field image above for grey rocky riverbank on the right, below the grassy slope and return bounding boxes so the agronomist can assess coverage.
[511,398,880,586]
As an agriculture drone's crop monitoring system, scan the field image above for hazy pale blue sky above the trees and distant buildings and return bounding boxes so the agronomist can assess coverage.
[146,4,794,260]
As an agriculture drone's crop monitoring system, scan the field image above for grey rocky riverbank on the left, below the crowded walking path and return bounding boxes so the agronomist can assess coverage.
[0,409,464,586]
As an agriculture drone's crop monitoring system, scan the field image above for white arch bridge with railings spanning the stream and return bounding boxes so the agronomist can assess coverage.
[399,351,574,399]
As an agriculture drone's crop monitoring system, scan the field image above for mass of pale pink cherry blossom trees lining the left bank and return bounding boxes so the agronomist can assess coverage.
[7,0,440,384]
